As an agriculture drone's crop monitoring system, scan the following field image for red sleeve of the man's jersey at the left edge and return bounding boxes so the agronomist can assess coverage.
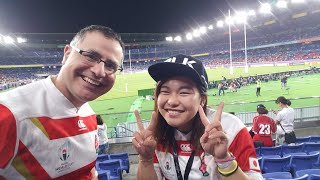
[0,104,17,169]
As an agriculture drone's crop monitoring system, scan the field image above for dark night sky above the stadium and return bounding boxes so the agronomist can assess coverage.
[0,0,259,34]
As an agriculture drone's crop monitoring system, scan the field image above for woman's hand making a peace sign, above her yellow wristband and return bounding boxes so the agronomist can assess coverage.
[199,102,228,159]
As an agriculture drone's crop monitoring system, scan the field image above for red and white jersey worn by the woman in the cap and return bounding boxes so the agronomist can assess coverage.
[153,110,263,180]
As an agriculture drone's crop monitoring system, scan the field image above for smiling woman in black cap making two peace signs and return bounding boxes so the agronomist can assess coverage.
[132,55,262,179]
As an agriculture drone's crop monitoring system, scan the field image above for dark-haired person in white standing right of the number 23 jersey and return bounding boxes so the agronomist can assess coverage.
[274,96,294,145]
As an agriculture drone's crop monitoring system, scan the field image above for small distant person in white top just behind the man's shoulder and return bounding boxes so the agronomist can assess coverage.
[96,115,109,155]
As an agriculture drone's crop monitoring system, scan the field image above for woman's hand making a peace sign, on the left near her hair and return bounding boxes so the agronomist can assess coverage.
[132,110,157,161]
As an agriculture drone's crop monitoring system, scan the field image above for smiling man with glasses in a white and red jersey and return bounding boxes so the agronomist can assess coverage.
[0,25,124,179]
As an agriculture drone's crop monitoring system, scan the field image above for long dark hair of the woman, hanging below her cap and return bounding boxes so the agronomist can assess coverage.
[154,80,207,152]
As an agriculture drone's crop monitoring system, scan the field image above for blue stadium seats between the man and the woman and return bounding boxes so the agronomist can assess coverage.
[96,152,130,180]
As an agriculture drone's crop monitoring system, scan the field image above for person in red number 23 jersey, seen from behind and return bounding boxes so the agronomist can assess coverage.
[252,104,277,147]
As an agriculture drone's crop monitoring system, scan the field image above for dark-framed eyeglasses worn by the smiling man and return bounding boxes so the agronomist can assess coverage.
[70,45,123,74]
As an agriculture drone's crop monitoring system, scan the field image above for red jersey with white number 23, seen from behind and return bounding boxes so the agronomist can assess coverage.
[252,115,277,137]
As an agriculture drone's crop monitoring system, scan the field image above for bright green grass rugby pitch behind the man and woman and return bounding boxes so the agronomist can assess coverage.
[90,65,320,127]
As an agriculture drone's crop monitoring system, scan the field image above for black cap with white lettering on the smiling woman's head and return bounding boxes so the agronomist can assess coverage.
[148,54,208,92]
